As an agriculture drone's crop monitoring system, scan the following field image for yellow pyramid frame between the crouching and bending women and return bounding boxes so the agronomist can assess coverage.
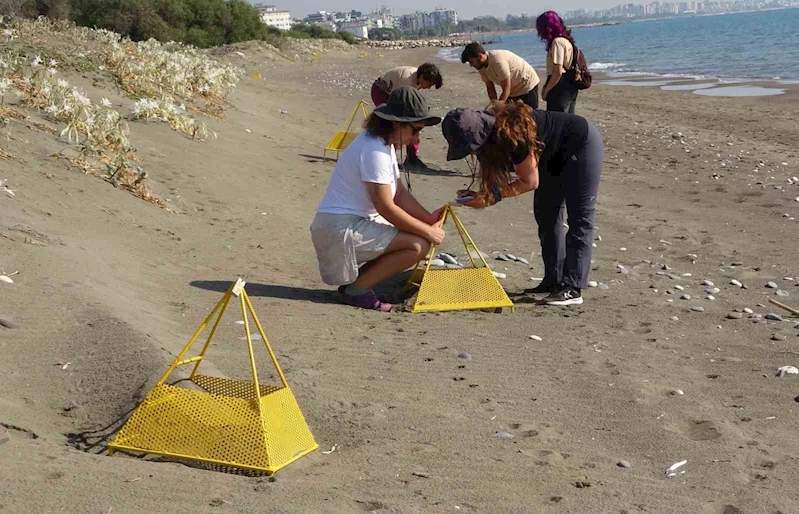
[406,206,513,312]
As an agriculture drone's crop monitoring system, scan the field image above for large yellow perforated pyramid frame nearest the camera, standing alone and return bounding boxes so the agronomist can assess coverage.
[108,279,318,475]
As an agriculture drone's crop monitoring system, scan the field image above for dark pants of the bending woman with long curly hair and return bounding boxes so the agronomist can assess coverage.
[533,121,605,289]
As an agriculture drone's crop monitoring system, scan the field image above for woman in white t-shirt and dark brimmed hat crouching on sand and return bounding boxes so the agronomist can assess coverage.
[311,86,444,312]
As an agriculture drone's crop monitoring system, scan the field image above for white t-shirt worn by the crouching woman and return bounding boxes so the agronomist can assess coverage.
[318,131,400,218]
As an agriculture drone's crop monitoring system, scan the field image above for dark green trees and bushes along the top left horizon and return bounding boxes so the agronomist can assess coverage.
[0,0,354,48]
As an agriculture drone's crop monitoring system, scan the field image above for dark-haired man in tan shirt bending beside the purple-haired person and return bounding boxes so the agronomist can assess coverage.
[461,43,540,109]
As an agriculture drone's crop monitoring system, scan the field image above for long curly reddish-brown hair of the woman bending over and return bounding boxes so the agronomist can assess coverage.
[476,100,543,192]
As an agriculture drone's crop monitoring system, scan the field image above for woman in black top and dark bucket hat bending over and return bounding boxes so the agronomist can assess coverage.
[442,102,604,305]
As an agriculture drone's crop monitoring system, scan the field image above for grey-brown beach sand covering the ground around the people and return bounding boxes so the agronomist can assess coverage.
[0,38,799,514]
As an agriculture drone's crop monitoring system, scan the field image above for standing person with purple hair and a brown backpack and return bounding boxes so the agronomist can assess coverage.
[535,11,578,114]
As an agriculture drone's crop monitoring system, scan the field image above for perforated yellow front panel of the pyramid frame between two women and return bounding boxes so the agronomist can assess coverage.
[412,268,513,312]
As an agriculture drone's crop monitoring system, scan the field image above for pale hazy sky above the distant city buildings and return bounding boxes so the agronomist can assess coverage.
[268,0,627,19]
